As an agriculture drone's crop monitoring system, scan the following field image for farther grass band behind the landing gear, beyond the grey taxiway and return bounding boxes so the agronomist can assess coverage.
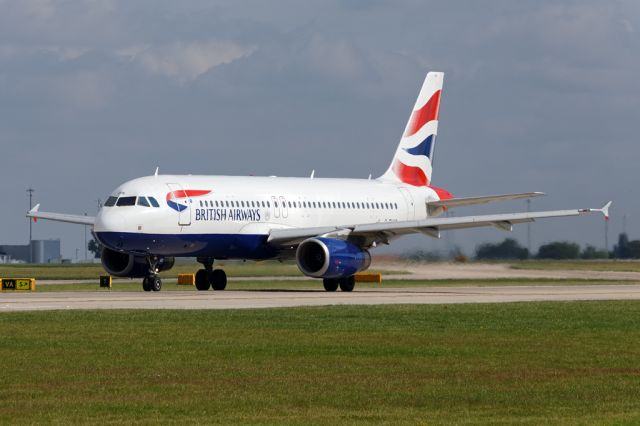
[0,261,406,280]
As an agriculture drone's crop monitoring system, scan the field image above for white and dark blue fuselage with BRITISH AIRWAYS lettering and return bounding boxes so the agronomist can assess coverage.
[94,175,439,259]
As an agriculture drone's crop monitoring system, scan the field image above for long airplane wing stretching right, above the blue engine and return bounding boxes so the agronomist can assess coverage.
[267,201,611,247]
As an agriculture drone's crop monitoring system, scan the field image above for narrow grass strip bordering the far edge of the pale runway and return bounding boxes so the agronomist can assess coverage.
[31,278,636,292]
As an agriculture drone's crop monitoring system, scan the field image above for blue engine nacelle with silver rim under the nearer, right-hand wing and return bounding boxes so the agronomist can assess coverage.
[296,237,371,278]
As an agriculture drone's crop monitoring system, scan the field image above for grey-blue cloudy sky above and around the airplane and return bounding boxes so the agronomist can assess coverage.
[0,0,640,259]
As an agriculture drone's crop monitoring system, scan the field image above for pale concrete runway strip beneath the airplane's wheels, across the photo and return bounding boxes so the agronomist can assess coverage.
[0,285,640,312]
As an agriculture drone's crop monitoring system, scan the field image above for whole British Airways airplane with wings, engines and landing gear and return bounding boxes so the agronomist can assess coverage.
[27,72,611,292]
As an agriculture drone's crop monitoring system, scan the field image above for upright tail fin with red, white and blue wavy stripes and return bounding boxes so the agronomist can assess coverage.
[381,72,444,186]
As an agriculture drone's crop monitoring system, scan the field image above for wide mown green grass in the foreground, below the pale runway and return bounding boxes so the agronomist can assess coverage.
[0,302,640,425]
